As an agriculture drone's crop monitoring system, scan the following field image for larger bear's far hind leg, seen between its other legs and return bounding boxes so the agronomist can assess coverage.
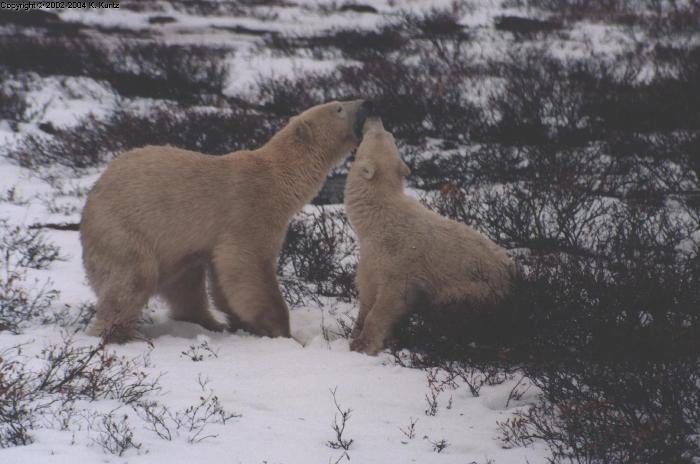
[158,265,226,332]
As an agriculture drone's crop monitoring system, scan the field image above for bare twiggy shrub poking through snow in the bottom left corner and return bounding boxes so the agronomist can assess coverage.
[0,337,160,452]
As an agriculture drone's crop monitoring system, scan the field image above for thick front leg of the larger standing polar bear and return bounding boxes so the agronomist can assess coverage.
[213,247,291,337]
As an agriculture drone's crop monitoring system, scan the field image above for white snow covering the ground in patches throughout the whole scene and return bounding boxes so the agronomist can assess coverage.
[0,0,696,464]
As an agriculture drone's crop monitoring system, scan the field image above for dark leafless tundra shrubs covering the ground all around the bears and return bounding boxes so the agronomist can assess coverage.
[0,0,700,464]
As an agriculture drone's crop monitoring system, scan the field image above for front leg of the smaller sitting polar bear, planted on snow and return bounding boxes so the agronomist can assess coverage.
[350,289,409,356]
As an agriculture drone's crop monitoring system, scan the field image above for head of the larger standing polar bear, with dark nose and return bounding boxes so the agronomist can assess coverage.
[290,100,372,157]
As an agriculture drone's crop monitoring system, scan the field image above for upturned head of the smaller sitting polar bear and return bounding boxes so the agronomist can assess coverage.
[350,117,411,189]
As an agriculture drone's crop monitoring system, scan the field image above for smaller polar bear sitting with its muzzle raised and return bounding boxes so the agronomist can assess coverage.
[345,117,515,355]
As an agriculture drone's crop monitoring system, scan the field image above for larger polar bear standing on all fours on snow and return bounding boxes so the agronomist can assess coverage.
[80,100,371,342]
